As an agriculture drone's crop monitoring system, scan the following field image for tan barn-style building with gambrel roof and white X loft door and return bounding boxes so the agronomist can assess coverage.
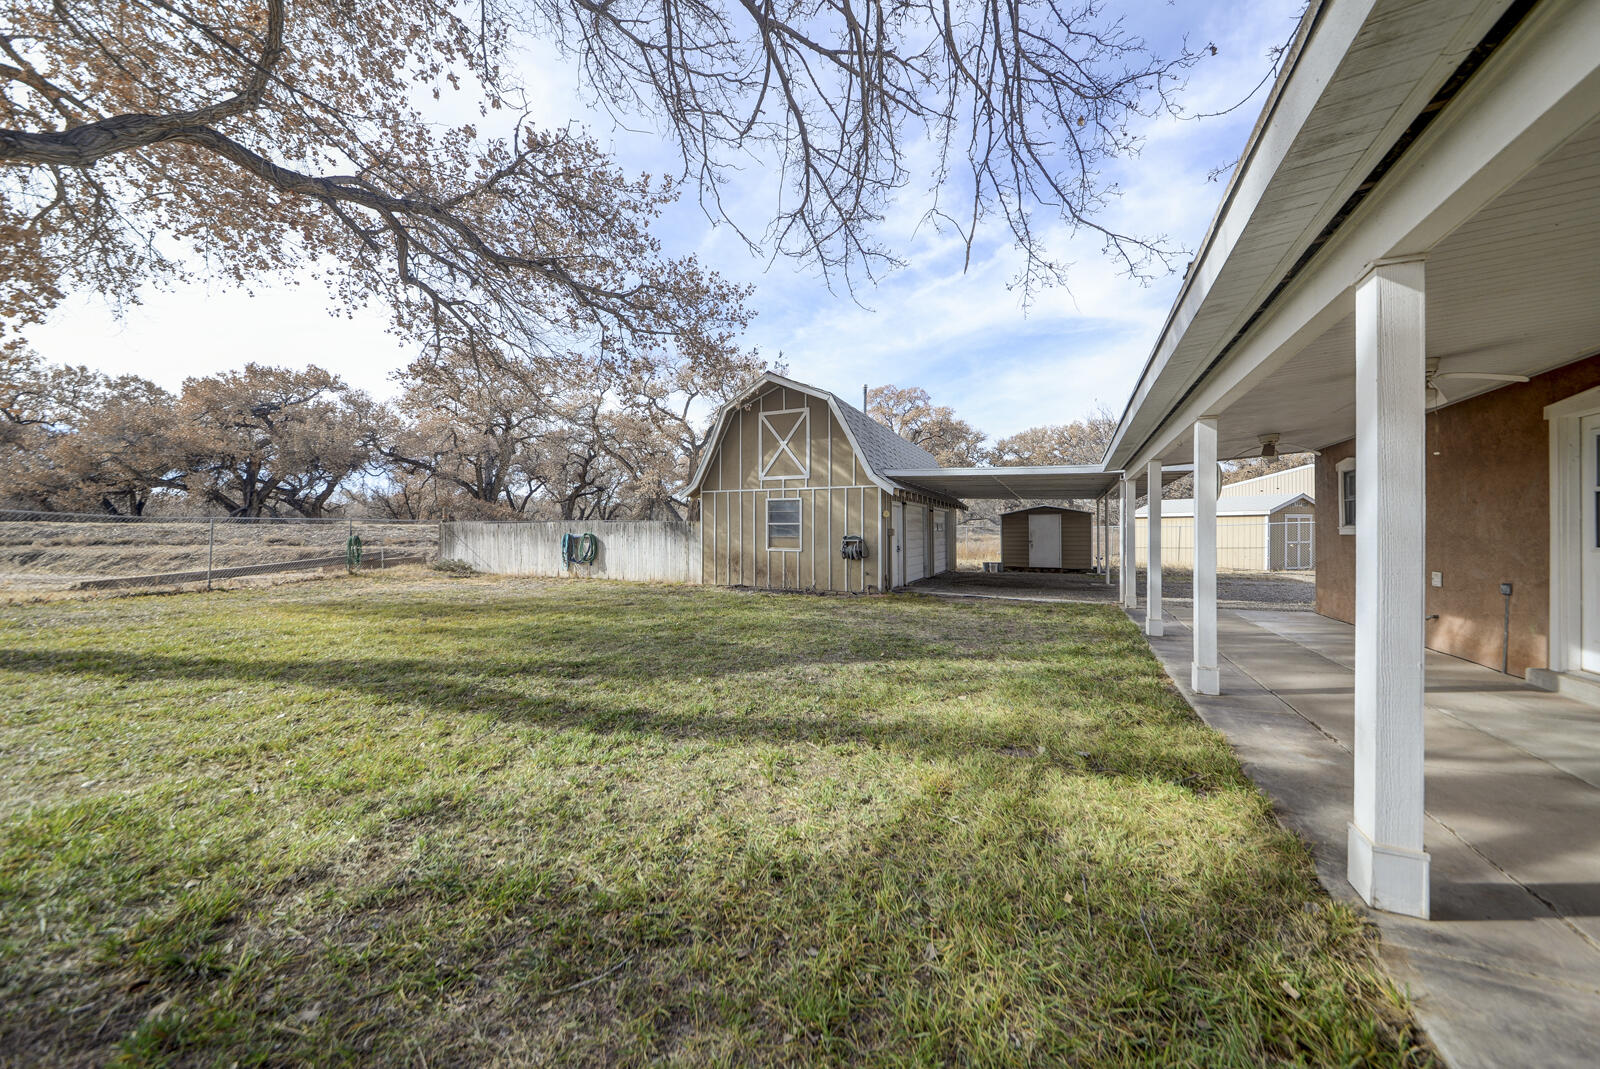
[683,373,963,592]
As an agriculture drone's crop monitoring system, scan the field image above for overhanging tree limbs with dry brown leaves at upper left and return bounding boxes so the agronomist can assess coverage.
[0,0,752,364]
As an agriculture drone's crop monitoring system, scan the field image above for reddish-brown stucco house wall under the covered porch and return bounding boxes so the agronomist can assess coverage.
[1317,348,1600,675]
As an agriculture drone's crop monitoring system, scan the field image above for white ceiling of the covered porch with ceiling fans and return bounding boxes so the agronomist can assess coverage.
[1163,112,1600,461]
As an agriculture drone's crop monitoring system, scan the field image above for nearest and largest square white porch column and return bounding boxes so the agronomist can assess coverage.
[1349,259,1429,917]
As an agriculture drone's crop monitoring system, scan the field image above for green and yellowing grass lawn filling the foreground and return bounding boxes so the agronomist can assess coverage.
[0,571,1429,1066]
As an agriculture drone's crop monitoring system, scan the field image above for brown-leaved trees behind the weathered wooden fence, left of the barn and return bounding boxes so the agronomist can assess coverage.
[374,334,765,518]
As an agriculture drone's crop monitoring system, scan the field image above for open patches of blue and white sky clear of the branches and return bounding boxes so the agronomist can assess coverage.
[32,0,1302,437]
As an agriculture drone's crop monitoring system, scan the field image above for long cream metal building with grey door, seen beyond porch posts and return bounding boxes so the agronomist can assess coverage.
[1134,496,1317,571]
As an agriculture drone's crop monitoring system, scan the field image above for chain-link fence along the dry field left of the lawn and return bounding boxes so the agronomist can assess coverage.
[0,509,438,592]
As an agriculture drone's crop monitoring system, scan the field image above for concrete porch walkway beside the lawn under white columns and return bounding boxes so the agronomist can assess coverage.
[1134,610,1600,1069]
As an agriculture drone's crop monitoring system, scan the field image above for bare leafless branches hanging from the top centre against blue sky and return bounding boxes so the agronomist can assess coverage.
[521,0,1216,288]
